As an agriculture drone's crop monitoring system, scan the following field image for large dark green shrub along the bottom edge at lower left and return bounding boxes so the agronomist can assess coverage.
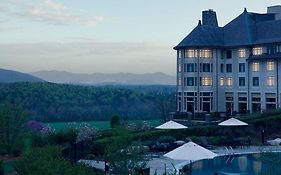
[15,147,98,175]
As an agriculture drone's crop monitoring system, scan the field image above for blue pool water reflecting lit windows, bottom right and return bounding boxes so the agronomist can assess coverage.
[188,153,281,175]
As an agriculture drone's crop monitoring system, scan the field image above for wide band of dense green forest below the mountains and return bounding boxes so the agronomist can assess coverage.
[0,83,175,122]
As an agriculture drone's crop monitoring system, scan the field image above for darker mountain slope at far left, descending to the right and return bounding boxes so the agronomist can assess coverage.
[0,69,44,83]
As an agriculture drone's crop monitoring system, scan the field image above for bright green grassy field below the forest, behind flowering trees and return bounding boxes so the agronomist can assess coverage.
[45,120,161,131]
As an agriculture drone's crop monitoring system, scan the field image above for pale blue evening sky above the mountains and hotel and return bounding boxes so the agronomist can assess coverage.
[0,0,281,75]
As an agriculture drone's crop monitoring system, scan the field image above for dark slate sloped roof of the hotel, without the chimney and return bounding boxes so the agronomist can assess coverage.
[174,10,281,49]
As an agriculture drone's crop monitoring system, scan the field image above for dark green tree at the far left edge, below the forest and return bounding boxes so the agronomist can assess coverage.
[0,103,26,154]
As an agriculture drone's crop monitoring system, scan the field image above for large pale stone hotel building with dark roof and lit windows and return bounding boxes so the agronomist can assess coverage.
[174,6,281,113]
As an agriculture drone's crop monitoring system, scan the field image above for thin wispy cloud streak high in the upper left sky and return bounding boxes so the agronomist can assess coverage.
[10,0,104,27]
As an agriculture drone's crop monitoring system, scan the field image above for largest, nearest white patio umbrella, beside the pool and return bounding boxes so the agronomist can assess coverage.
[164,141,217,161]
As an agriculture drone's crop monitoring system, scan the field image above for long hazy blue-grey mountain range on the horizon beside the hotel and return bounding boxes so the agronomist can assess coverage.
[30,70,176,85]
